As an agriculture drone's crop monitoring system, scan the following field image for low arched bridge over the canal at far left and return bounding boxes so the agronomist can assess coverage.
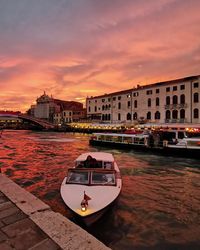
[0,112,55,129]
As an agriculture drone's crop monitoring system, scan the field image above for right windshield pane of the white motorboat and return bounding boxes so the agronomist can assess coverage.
[91,171,115,185]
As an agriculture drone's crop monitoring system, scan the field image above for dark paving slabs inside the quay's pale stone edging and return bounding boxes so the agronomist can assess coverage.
[0,192,61,250]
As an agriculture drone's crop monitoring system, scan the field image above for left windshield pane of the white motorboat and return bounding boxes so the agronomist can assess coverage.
[67,170,89,184]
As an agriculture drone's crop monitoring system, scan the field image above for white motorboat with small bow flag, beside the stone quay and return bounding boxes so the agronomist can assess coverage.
[61,152,122,225]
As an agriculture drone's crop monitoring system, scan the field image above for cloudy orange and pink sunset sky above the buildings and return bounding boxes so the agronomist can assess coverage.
[0,0,200,111]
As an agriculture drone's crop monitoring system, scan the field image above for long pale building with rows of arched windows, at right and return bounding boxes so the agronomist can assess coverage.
[86,75,200,124]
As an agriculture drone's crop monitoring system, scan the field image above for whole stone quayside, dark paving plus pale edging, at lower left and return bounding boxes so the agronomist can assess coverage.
[0,174,109,250]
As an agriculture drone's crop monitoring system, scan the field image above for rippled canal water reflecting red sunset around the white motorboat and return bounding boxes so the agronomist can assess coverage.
[0,130,200,250]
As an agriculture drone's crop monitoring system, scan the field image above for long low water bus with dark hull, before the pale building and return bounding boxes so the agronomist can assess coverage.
[89,130,200,158]
